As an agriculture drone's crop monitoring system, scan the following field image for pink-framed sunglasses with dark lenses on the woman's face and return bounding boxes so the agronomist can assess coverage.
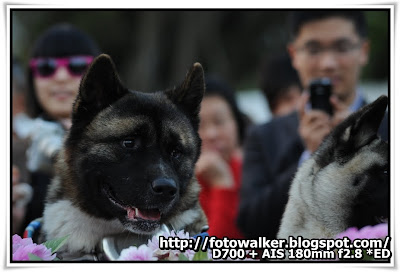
[29,56,93,78]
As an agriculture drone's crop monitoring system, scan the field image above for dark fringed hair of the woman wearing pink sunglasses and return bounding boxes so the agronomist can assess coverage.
[27,23,101,118]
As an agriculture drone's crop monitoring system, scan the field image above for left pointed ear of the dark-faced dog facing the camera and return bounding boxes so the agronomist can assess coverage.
[72,54,128,122]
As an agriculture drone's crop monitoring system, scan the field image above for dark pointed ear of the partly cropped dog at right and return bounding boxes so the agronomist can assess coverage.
[340,95,388,149]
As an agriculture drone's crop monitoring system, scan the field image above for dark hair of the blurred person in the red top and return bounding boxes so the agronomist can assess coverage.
[204,76,249,144]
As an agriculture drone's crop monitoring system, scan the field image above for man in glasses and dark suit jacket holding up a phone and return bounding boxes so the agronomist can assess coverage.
[237,10,388,239]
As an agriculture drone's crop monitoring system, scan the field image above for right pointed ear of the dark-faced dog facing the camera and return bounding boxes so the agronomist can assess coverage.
[165,62,205,130]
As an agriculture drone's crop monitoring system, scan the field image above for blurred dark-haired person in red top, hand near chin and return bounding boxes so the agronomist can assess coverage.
[195,77,246,239]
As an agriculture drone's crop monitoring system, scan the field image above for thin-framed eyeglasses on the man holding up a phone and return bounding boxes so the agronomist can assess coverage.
[297,40,362,57]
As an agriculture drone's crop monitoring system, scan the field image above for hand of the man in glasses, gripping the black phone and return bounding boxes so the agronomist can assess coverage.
[298,93,332,153]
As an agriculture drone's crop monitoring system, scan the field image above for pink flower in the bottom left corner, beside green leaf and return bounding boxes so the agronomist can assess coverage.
[12,234,56,261]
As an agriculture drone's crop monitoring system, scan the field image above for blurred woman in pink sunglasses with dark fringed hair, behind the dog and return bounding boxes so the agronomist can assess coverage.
[14,24,100,233]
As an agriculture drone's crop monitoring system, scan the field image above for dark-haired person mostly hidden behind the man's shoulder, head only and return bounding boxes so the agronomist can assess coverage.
[260,54,302,117]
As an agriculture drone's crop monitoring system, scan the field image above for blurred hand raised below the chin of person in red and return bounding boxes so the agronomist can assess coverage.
[195,150,234,188]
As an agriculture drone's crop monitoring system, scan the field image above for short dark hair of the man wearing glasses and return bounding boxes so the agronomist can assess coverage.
[288,9,368,40]
